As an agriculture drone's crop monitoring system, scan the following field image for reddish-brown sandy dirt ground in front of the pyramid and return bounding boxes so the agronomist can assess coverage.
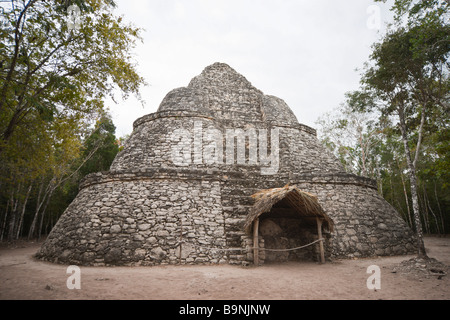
[0,237,450,300]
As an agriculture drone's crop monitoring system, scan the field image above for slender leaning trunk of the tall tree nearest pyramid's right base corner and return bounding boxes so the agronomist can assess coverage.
[398,106,428,259]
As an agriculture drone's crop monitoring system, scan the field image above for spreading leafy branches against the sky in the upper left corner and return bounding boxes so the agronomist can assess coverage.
[0,0,145,153]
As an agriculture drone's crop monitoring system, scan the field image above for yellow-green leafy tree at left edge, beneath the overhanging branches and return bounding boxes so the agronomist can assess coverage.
[0,109,81,240]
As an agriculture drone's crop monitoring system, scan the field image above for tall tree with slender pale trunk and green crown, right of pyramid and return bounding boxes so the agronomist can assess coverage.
[356,0,450,257]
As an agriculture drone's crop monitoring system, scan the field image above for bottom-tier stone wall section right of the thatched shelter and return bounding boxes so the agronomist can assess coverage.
[297,183,415,257]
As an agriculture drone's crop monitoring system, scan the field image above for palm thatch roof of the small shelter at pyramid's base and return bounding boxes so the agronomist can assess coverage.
[244,185,333,234]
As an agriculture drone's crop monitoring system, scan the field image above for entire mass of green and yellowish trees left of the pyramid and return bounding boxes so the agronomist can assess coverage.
[0,0,145,240]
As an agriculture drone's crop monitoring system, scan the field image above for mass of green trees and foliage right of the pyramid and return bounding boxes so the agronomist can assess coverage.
[319,0,450,233]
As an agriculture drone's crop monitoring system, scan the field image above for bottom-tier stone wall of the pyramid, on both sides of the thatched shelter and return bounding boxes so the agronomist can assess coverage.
[39,141,414,265]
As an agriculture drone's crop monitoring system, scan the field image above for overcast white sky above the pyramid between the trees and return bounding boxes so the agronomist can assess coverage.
[105,0,392,136]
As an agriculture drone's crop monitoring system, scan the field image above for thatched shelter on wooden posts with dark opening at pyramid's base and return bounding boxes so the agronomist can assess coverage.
[245,186,333,264]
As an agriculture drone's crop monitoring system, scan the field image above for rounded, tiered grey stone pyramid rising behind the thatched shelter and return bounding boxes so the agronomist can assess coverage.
[36,63,415,265]
